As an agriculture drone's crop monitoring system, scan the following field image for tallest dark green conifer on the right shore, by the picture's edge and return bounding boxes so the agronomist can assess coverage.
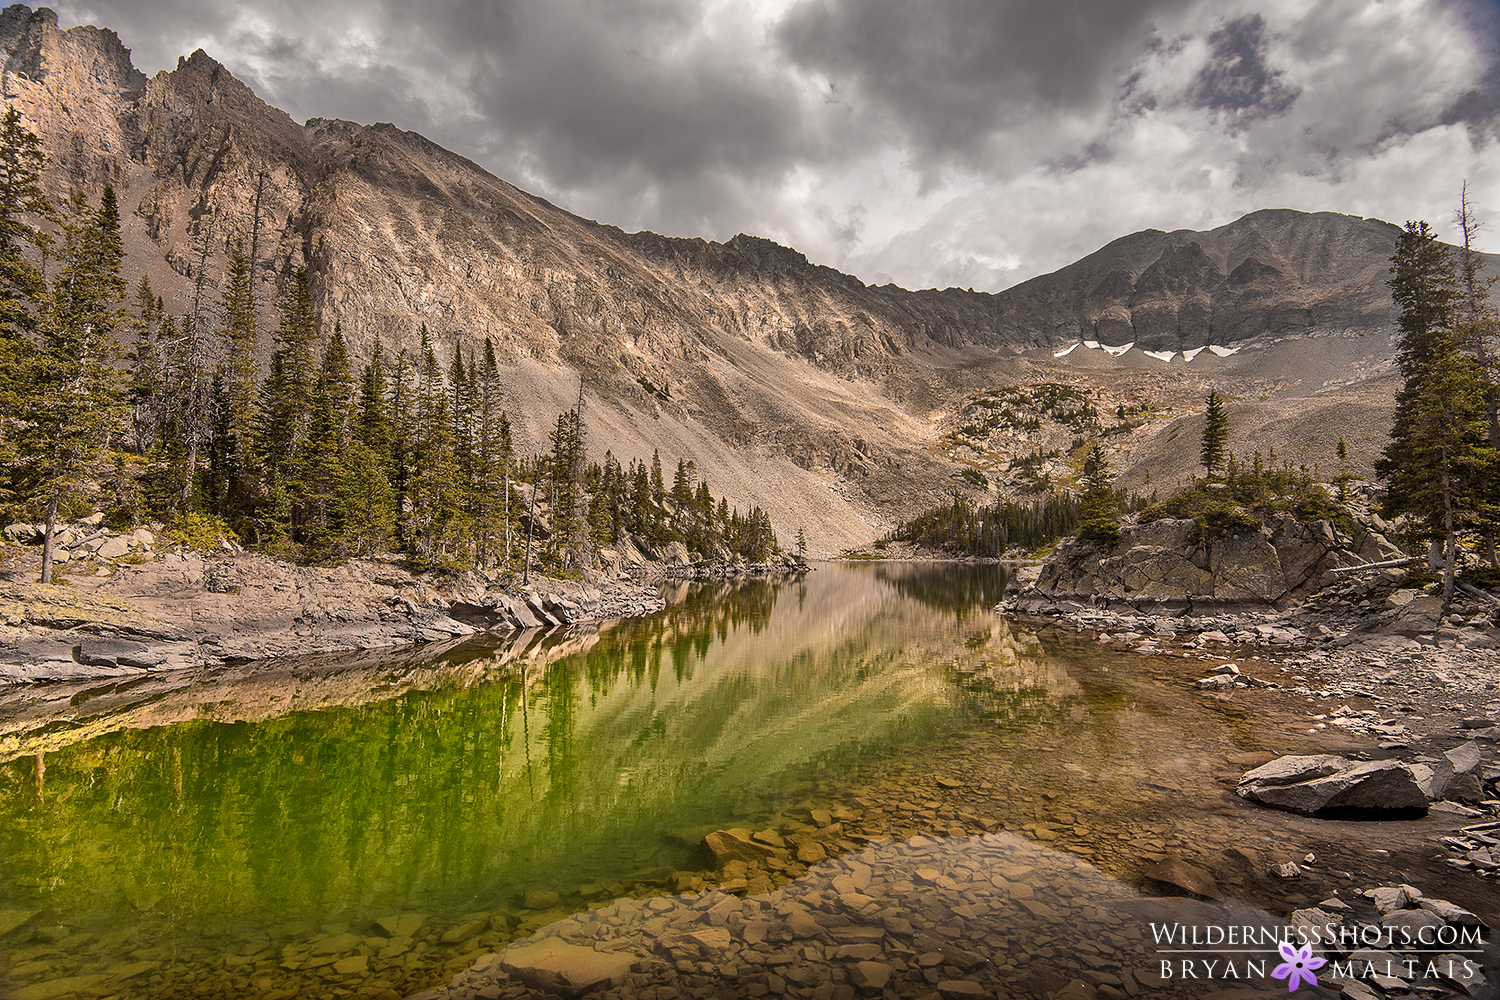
[1376,222,1496,604]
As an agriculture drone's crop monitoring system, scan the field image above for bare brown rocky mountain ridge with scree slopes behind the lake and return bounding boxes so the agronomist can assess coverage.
[0,4,1428,550]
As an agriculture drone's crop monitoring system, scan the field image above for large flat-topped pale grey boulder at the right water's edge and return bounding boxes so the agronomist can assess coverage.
[1238,754,1428,816]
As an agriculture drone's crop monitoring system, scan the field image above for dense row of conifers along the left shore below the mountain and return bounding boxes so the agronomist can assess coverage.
[0,108,780,582]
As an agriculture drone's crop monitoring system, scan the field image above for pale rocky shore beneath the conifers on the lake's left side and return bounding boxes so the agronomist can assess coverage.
[0,522,665,684]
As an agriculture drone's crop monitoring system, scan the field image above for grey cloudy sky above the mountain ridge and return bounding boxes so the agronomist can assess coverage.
[54,0,1500,291]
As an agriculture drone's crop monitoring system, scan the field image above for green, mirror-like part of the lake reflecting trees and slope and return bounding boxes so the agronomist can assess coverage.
[0,567,1004,997]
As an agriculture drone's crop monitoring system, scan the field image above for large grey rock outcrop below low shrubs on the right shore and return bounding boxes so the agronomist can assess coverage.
[1014,514,1401,610]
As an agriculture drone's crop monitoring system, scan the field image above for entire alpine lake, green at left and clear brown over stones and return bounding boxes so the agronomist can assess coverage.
[0,562,1494,1000]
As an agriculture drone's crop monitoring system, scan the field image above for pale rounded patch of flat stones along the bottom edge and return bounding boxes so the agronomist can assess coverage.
[411,834,1484,1000]
